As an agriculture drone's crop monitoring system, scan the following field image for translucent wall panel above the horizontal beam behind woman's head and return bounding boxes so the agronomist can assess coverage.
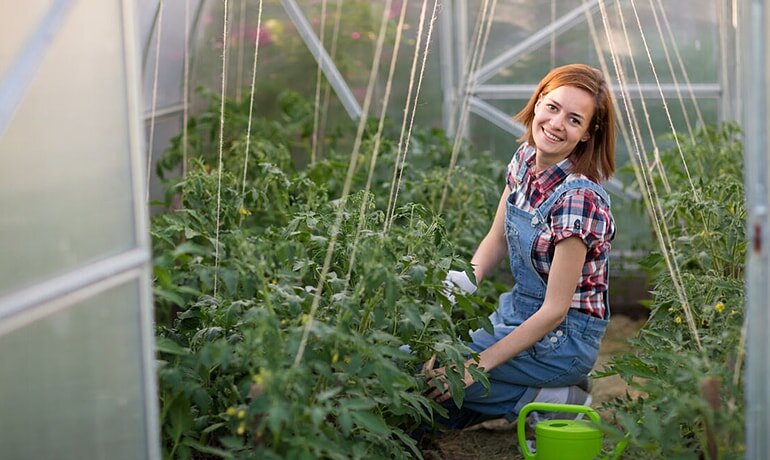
[486,0,719,84]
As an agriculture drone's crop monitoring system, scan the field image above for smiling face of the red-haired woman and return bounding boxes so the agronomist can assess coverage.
[532,86,595,168]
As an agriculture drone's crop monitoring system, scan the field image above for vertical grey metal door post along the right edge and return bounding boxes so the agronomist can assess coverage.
[738,0,770,459]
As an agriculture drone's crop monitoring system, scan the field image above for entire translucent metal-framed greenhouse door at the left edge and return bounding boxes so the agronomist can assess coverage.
[0,0,158,459]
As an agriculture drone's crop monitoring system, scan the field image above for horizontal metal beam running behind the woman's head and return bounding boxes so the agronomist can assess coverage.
[471,83,722,100]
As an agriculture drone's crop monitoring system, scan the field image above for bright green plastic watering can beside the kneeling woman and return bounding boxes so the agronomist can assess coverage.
[518,402,627,460]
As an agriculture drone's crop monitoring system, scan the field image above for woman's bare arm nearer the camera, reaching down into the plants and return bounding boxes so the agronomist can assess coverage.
[426,235,588,402]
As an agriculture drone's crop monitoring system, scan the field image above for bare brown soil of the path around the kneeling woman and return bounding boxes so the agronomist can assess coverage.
[424,315,645,460]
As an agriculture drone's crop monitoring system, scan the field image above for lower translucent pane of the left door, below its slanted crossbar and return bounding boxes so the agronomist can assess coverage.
[0,281,148,460]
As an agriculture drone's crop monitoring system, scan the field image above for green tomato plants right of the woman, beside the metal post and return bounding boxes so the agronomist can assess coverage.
[605,124,746,459]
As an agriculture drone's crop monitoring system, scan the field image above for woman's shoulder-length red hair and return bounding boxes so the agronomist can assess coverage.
[513,64,615,181]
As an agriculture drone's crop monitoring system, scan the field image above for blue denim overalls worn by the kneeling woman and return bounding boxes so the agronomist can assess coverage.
[449,178,610,425]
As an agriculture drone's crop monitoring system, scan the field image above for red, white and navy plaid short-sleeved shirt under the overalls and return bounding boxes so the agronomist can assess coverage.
[506,142,615,318]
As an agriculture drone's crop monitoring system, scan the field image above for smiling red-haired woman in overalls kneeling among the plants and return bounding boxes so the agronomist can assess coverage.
[424,64,615,428]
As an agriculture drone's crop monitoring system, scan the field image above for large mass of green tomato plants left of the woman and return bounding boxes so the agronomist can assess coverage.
[152,93,504,458]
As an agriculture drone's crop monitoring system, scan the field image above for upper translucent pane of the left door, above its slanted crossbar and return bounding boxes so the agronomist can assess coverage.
[0,0,136,296]
